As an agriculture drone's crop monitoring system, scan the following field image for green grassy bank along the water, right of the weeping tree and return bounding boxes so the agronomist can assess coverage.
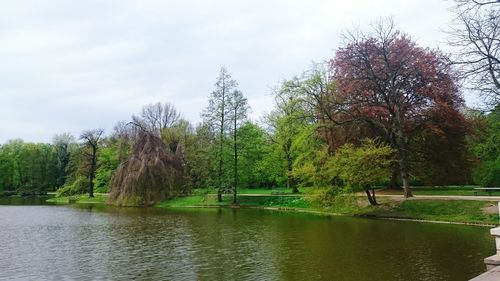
[156,190,499,225]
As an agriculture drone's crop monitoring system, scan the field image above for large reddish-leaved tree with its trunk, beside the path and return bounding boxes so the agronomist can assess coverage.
[331,21,463,197]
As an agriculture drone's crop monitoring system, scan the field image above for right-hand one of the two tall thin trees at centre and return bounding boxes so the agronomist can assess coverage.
[228,90,248,201]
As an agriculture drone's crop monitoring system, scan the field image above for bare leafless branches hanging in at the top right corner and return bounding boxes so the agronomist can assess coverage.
[449,0,500,107]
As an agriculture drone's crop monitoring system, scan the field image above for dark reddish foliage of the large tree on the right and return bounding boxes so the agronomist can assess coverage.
[330,28,467,186]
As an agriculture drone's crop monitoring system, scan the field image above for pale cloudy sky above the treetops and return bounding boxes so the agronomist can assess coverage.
[0,0,470,143]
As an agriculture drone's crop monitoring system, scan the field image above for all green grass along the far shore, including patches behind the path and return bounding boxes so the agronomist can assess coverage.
[47,186,499,225]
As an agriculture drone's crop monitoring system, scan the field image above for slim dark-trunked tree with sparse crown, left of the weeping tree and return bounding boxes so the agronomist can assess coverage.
[80,129,104,197]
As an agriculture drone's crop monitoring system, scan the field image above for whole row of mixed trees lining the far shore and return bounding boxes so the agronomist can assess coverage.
[0,1,500,205]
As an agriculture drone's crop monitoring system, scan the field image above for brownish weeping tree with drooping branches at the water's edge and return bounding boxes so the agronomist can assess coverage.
[108,130,184,206]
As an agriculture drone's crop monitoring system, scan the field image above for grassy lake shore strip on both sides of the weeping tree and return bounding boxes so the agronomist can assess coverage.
[47,193,499,227]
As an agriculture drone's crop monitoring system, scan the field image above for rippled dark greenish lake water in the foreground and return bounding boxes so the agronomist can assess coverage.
[0,198,495,281]
